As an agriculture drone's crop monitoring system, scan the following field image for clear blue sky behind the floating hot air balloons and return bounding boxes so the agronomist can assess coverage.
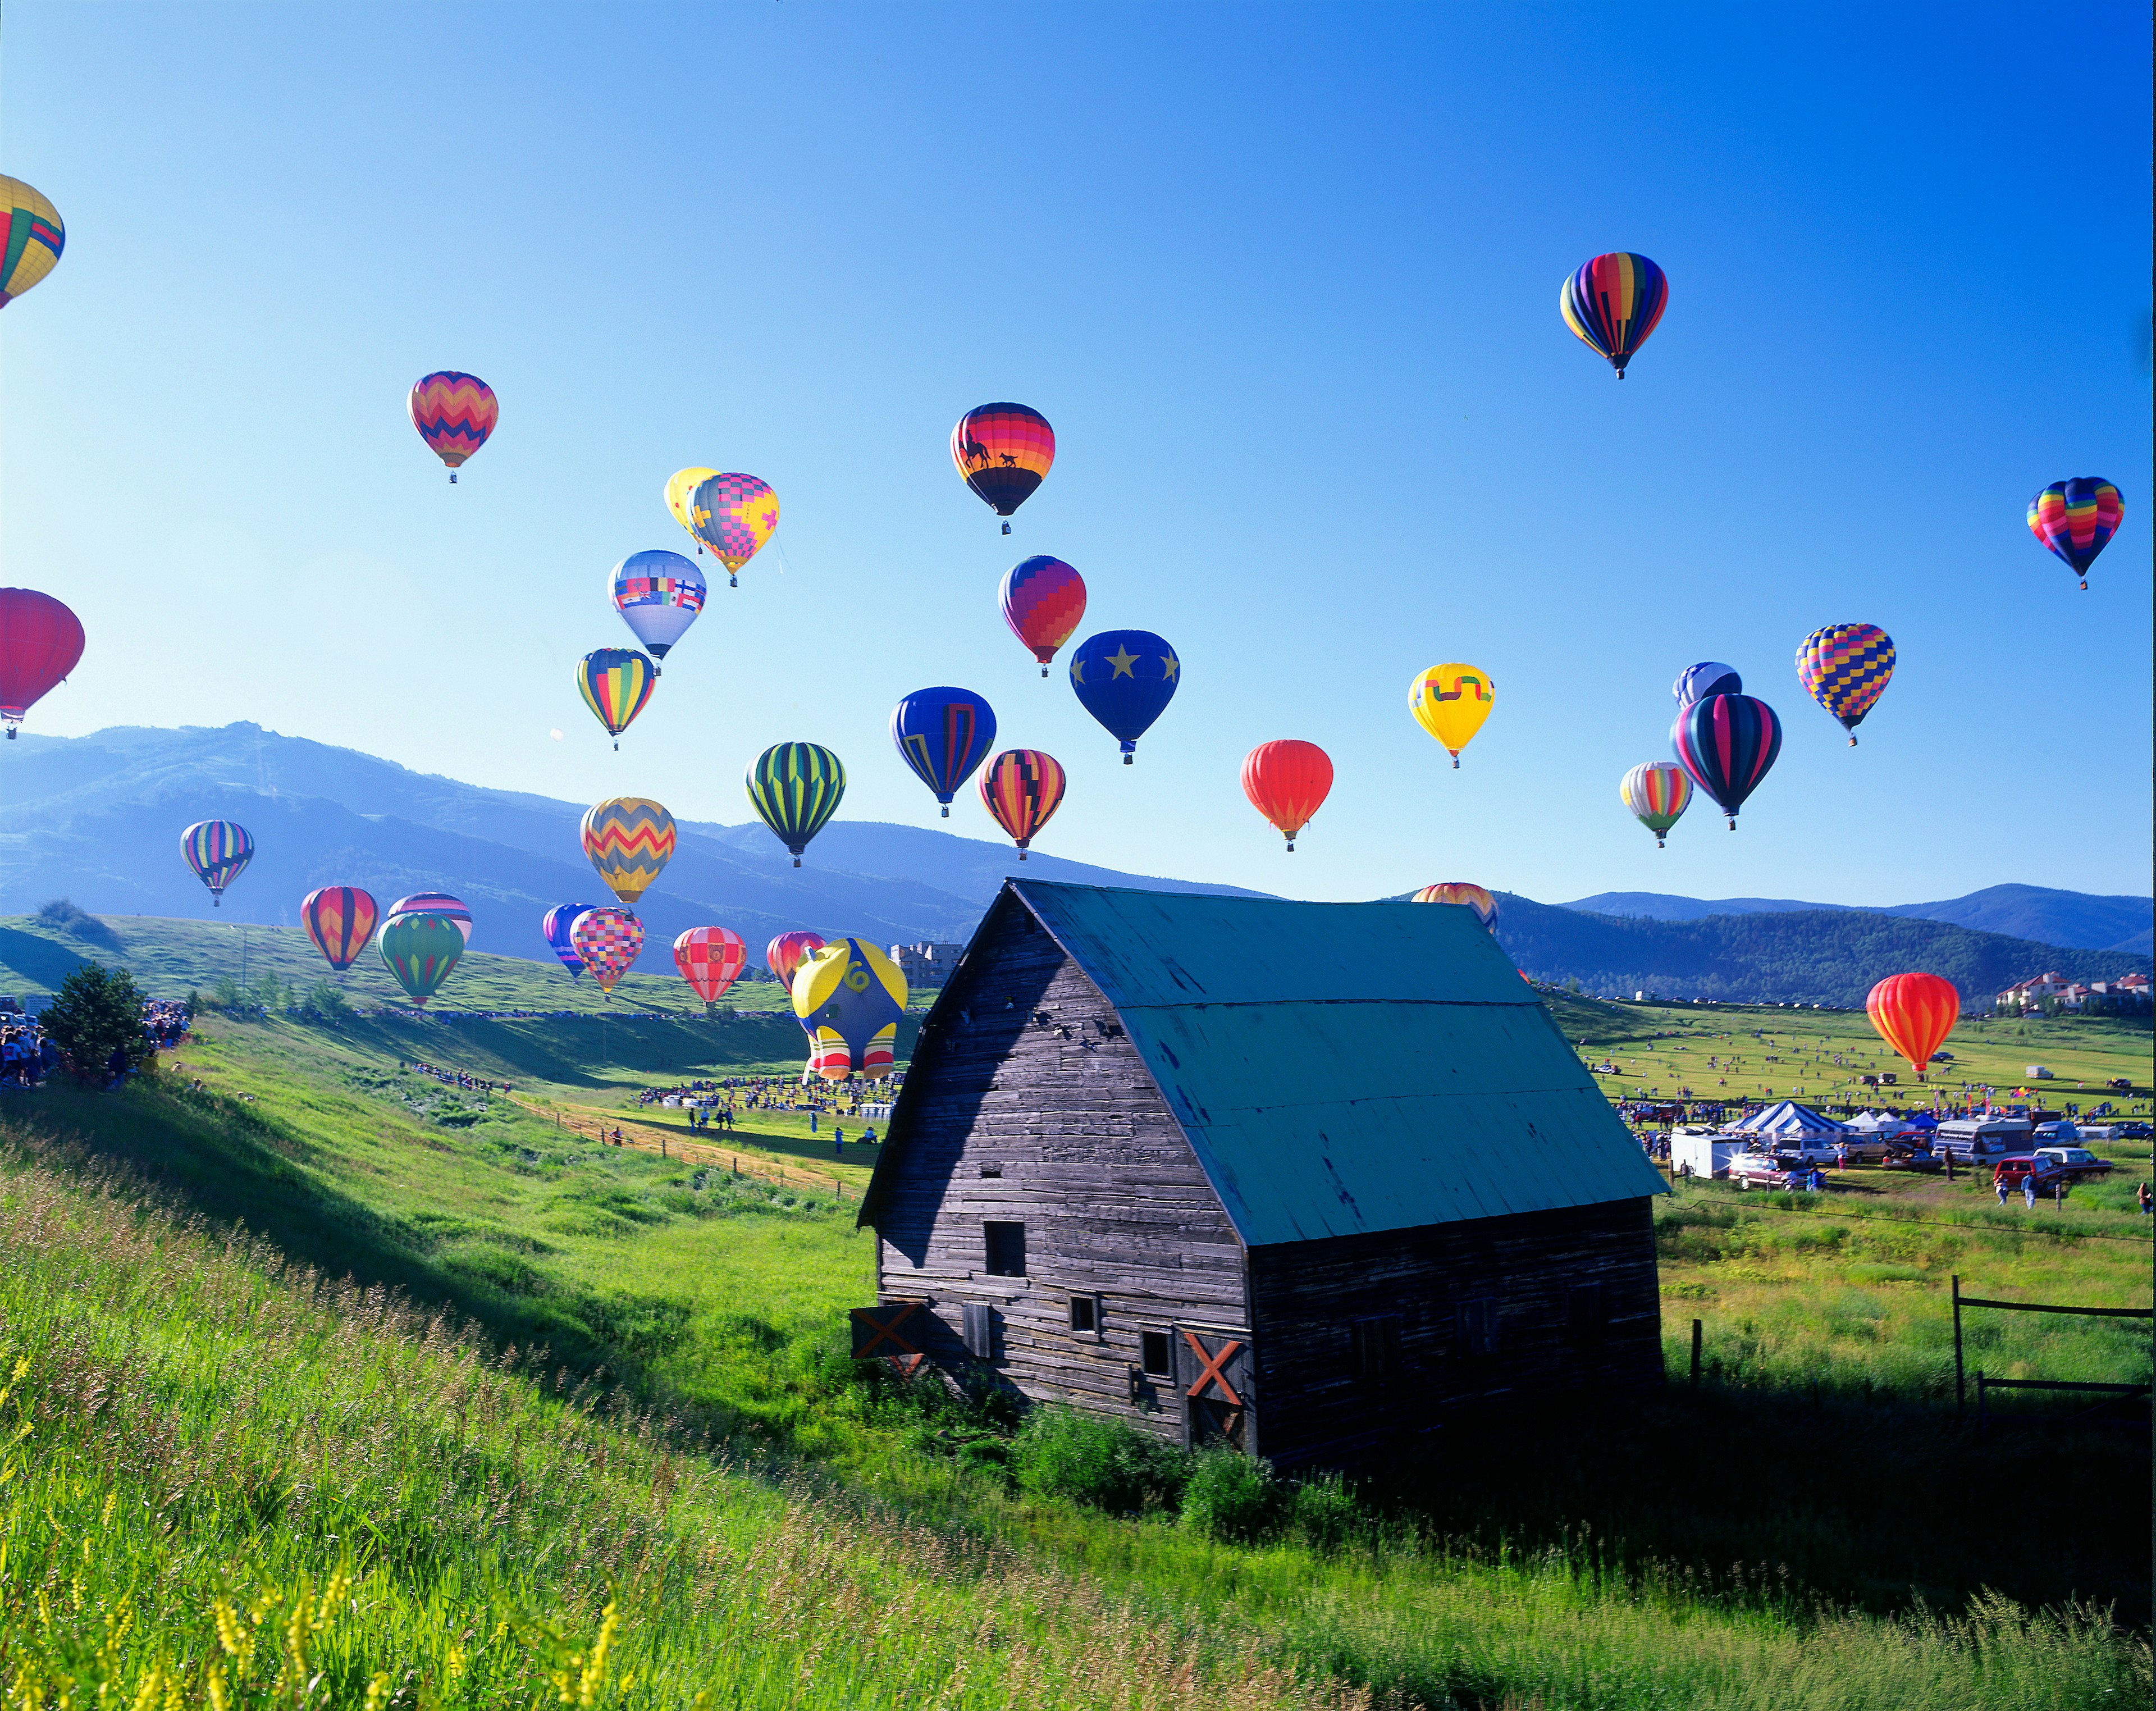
[0,0,2152,902]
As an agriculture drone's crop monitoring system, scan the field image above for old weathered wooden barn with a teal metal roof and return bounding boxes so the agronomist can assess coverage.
[854,880,1662,1465]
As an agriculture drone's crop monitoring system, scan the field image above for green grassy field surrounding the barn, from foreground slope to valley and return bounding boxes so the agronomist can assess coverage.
[0,921,2152,1711]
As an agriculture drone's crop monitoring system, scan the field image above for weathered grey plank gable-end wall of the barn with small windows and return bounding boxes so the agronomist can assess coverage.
[875,893,1248,1439]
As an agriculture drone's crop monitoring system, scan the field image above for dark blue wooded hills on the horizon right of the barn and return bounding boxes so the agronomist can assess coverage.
[1499,896,2149,1006]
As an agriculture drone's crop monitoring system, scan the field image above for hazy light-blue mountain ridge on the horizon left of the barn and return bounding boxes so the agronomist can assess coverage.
[0,723,1259,979]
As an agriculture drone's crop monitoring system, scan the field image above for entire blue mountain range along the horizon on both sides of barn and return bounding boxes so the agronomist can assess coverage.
[0,723,2149,1003]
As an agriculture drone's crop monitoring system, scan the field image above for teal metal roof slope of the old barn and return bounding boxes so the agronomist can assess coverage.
[1009,880,1666,1247]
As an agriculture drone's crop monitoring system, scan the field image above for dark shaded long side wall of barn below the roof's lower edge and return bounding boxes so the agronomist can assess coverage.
[1250,1199,1662,1465]
